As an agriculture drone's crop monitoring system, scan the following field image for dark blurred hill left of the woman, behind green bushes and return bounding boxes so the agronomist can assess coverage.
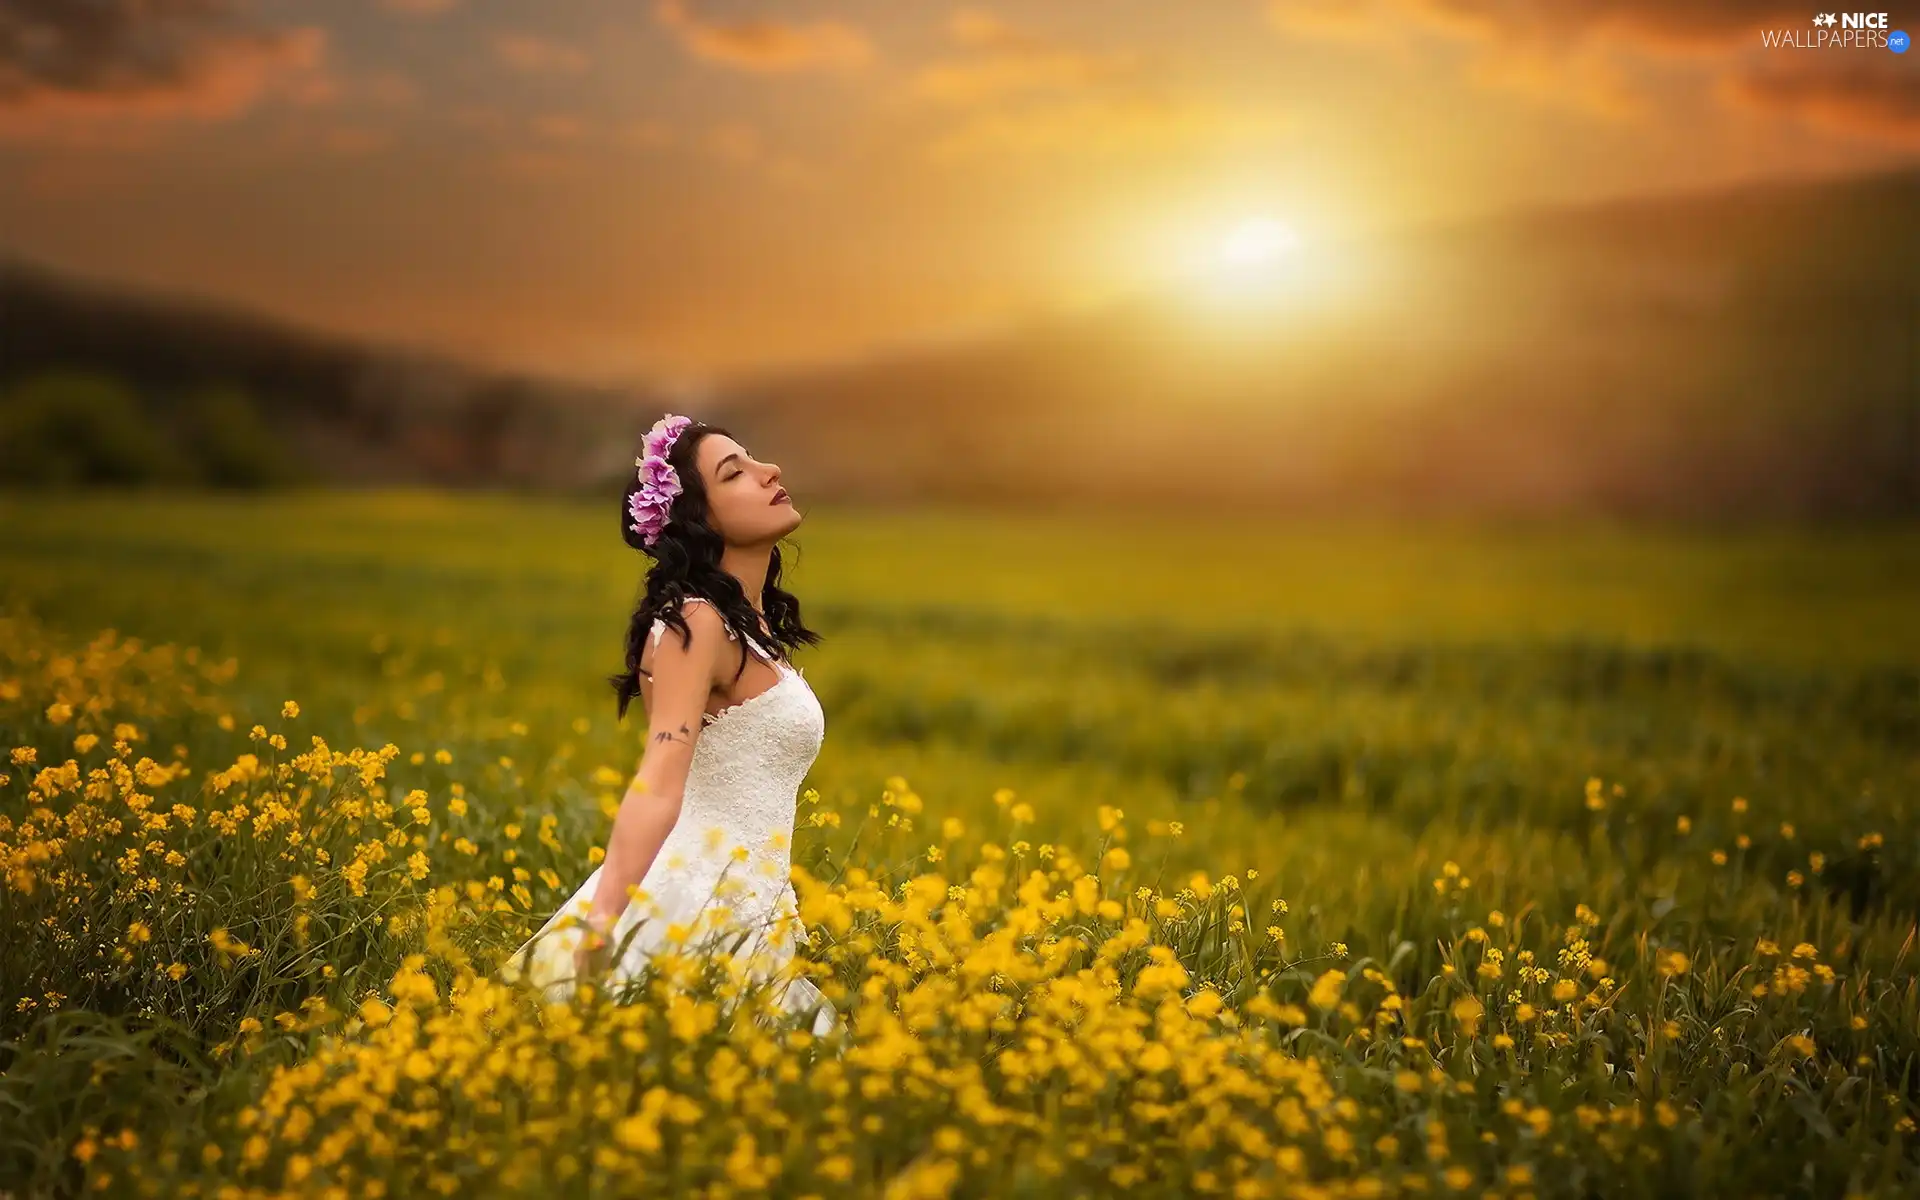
[0,261,651,490]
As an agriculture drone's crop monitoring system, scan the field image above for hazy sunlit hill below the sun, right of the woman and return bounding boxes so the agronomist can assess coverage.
[714,162,1920,518]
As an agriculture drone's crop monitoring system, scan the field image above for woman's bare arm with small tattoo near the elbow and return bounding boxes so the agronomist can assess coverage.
[568,605,728,960]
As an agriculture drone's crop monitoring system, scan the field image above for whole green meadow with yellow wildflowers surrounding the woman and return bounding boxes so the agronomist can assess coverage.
[0,492,1920,1198]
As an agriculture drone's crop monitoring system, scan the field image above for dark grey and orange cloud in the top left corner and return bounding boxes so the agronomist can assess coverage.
[0,0,336,138]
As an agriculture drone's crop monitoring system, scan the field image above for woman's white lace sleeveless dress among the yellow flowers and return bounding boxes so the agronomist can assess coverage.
[499,597,839,1035]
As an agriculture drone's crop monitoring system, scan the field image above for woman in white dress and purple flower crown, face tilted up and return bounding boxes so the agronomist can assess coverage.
[501,415,839,1033]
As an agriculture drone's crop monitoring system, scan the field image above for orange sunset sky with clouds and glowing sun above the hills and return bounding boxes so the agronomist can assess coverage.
[0,0,1920,380]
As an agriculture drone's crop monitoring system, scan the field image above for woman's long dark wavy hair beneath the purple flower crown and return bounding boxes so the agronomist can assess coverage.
[607,420,820,718]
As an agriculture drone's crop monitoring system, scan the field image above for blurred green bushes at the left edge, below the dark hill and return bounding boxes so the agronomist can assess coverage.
[0,369,315,490]
